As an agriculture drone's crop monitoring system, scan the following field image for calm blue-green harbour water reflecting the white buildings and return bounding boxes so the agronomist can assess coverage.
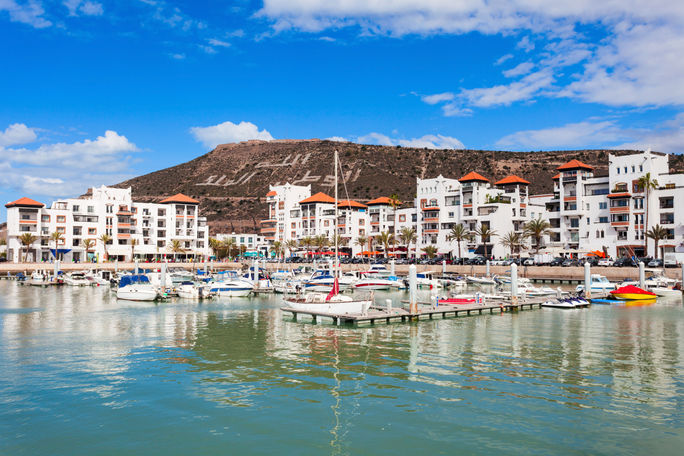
[0,282,684,455]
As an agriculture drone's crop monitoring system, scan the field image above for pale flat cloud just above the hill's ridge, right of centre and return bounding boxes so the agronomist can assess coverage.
[496,120,627,150]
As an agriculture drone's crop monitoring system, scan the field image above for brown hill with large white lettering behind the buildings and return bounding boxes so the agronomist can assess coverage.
[116,139,684,233]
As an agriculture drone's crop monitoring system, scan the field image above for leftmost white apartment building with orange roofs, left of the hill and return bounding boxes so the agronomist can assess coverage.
[5,186,209,262]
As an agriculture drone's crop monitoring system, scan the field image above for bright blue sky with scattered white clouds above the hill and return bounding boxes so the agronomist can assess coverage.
[0,0,684,220]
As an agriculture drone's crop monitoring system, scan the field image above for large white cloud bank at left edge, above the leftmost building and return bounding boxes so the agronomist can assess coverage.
[0,128,139,197]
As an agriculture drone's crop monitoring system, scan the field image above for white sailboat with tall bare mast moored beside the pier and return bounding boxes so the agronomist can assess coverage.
[283,150,373,315]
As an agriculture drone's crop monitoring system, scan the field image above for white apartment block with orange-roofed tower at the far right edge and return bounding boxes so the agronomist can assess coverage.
[544,151,684,257]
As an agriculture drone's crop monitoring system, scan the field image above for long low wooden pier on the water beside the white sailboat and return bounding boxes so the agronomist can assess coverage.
[280,300,543,326]
